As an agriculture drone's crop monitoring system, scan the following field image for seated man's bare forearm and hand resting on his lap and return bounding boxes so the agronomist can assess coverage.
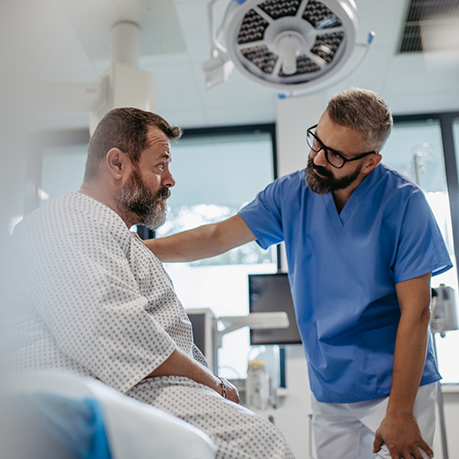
[147,349,239,403]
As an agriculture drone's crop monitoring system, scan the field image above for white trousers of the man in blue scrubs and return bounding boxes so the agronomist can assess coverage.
[311,383,437,459]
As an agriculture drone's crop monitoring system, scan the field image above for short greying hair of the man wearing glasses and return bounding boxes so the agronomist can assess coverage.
[326,88,393,151]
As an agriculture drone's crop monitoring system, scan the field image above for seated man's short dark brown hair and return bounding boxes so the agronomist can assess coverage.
[84,108,182,180]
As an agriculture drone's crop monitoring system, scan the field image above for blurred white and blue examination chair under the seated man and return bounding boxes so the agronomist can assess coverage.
[0,371,217,459]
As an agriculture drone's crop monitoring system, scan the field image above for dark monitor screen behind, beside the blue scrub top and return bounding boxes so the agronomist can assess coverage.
[249,273,301,346]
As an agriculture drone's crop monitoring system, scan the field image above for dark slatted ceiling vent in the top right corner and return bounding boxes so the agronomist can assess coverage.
[398,0,459,54]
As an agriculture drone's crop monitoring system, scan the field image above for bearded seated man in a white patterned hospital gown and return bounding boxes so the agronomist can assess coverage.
[9,108,293,459]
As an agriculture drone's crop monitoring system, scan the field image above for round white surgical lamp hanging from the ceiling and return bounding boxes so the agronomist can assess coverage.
[203,0,374,95]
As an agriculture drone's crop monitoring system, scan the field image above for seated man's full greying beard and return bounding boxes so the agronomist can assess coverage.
[116,168,171,231]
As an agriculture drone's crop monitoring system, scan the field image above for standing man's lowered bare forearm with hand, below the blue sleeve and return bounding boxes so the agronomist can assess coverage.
[374,273,433,459]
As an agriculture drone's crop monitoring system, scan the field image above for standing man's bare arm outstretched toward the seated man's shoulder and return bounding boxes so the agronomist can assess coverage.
[144,215,256,262]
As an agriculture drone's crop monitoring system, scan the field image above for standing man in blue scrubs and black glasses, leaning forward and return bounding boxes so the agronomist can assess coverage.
[146,88,452,459]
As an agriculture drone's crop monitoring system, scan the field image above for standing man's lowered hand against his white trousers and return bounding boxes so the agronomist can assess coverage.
[373,414,433,459]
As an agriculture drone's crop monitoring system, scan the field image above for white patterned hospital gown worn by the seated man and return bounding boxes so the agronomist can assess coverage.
[9,193,293,459]
